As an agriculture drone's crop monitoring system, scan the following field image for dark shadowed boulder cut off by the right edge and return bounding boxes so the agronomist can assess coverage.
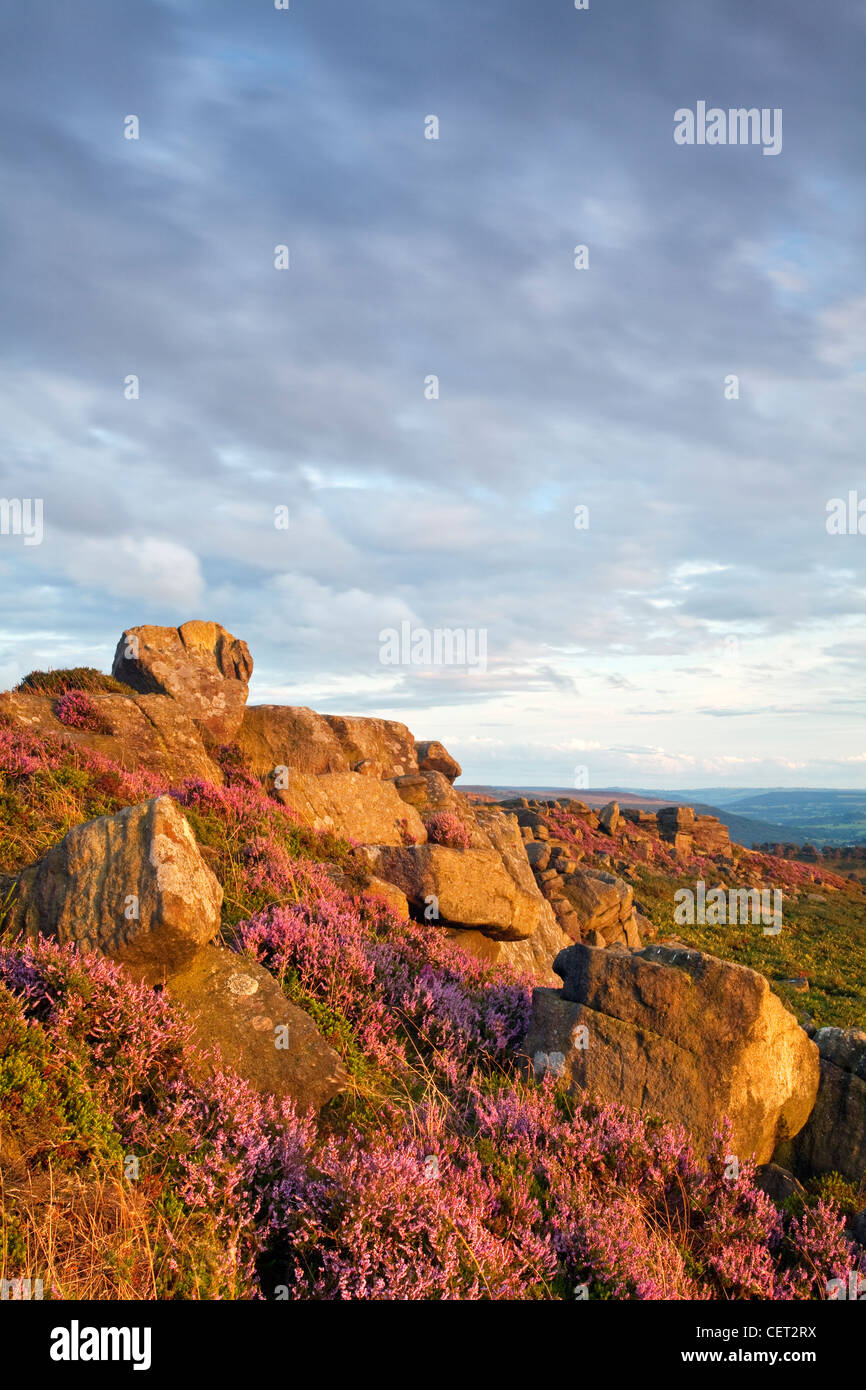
[778,1029,866,1183]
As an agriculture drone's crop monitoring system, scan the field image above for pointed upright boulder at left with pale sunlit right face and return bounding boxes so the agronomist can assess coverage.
[11,796,222,984]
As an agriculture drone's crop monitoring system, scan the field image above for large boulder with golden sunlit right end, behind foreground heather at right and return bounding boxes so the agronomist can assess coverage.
[525,945,819,1163]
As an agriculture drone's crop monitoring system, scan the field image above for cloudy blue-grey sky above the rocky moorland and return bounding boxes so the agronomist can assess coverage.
[0,0,866,788]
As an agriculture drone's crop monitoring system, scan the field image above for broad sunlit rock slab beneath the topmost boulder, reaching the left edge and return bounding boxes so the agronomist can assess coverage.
[0,691,224,785]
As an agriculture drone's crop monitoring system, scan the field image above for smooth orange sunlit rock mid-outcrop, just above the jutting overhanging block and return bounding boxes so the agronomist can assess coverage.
[277,771,427,845]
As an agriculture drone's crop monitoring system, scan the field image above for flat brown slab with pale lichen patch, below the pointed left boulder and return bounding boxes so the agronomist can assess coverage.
[165,947,348,1111]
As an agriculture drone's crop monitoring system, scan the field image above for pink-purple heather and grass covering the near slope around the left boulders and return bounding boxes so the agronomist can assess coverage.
[0,728,863,1300]
